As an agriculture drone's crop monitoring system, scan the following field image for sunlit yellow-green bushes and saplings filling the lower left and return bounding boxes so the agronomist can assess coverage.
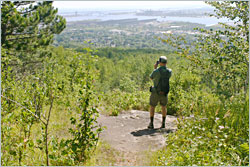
[1,48,101,165]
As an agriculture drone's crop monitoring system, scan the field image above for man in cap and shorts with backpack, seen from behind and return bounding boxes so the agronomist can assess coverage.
[148,56,172,129]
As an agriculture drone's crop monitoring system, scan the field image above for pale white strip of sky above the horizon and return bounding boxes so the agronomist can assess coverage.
[53,1,210,10]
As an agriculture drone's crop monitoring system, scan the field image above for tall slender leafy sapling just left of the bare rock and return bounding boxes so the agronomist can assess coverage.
[66,50,102,164]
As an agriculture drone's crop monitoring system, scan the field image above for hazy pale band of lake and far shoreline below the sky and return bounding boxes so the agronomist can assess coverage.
[60,8,227,26]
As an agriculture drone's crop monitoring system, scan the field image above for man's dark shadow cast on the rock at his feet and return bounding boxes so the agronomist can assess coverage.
[131,128,174,137]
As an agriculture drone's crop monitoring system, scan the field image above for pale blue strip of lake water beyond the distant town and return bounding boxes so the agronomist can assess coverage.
[61,12,231,26]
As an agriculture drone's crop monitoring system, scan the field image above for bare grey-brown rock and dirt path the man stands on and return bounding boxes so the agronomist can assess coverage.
[98,110,177,166]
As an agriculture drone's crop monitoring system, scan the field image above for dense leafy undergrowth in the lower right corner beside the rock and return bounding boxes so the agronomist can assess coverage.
[152,96,249,166]
